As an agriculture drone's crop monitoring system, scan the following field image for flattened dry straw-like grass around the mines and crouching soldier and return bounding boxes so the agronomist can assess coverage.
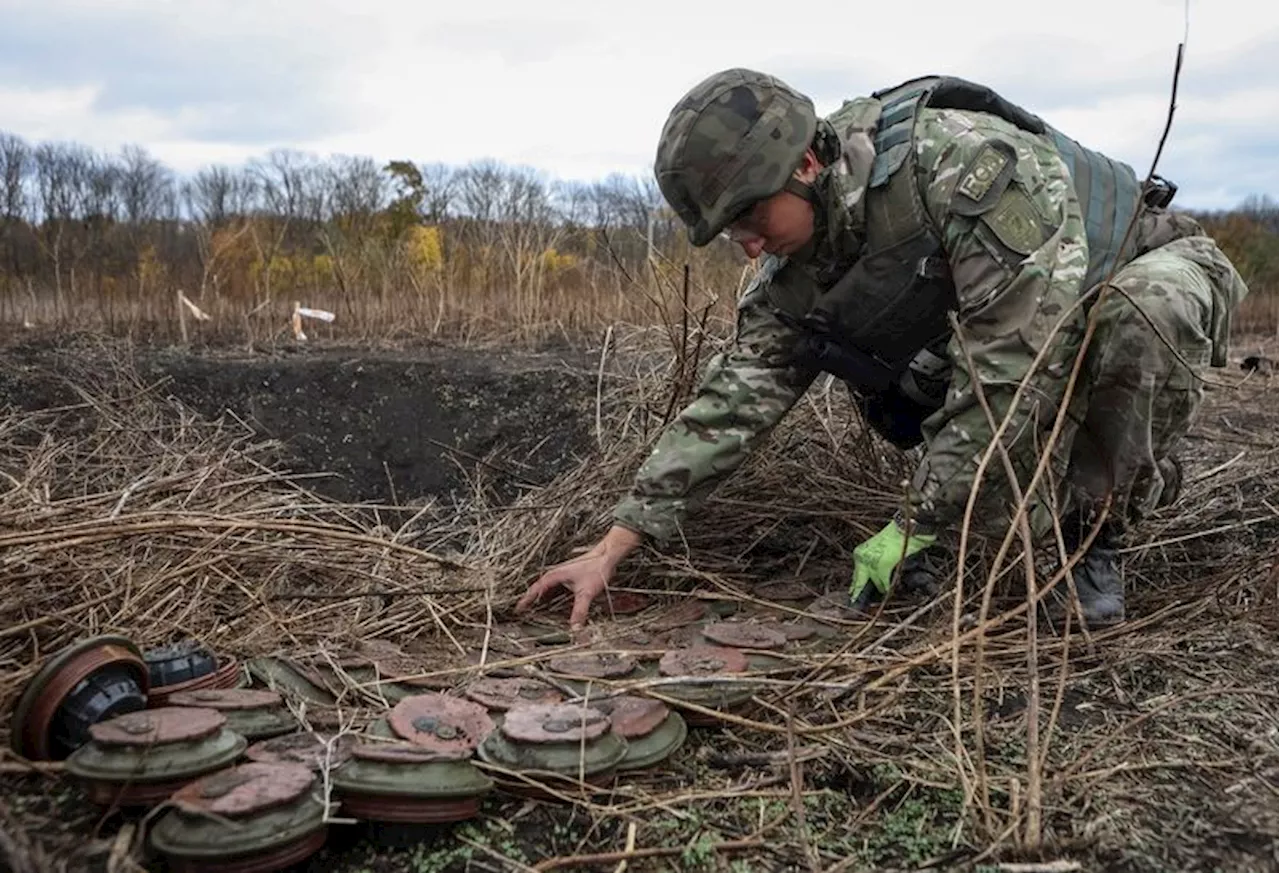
[0,330,1280,870]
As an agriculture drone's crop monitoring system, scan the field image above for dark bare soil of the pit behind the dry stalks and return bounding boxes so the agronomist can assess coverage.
[0,337,595,506]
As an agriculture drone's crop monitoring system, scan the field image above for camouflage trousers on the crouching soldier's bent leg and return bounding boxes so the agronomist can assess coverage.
[1066,236,1244,535]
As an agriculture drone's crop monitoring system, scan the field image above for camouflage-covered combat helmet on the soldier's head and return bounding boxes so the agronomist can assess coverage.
[654,69,818,246]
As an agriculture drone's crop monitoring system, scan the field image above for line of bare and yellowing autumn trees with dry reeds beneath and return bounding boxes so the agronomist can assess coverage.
[0,133,1280,338]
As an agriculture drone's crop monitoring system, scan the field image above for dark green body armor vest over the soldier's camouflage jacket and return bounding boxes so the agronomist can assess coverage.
[769,77,1142,417]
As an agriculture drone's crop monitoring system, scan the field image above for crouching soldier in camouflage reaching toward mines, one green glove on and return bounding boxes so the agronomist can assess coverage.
[517,69,1247,627]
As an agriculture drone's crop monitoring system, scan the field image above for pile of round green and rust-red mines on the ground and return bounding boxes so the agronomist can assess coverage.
[13,578,839,873]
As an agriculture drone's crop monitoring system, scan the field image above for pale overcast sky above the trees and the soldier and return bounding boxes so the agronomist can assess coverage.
[0,0,1280,209]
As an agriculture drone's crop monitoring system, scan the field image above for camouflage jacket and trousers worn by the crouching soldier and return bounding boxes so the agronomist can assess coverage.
[614,76,1247,550]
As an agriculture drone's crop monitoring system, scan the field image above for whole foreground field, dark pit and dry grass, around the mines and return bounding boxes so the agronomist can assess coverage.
[0,311,1280,873]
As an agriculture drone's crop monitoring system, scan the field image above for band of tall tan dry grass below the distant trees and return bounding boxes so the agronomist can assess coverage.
[0,227,745,348]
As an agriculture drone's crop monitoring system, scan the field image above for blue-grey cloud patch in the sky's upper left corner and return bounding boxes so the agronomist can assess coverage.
[0,3,344,146]
